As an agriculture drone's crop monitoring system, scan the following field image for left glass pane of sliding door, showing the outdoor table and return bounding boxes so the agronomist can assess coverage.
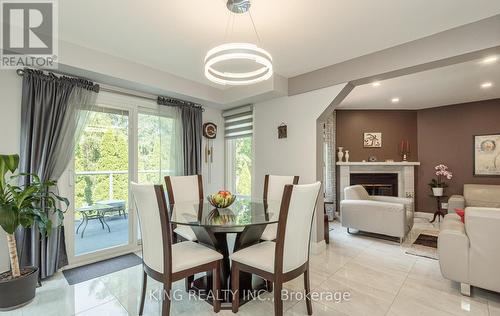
[74,107,130,256]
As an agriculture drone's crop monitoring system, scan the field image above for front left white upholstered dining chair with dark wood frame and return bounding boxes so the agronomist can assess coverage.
[131,182,222,316]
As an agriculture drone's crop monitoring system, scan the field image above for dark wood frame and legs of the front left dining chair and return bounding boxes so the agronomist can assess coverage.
[139,185,221,316]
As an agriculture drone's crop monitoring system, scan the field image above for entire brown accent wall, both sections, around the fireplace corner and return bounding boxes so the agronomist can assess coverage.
[336,99,500,212]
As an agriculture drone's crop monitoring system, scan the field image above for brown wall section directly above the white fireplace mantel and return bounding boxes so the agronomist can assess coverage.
[336,110,418,161]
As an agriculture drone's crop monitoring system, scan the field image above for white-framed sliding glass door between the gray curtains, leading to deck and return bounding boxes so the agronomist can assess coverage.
[63,92,183,266]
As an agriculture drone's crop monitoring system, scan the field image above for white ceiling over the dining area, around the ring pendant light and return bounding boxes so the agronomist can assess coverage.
[59,0,500,88]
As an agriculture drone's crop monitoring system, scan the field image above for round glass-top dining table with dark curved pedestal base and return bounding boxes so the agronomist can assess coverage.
[170,199,280,309]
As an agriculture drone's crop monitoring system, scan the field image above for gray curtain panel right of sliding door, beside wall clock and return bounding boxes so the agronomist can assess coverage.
[158,97,203,176]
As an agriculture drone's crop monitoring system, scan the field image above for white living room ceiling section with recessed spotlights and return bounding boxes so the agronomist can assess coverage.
[339,52,500,110]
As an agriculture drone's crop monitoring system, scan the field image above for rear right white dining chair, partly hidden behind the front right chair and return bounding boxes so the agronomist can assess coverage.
[260,174,299,241]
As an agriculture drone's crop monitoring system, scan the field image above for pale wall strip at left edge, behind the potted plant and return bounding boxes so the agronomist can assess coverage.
[0,70,21,272]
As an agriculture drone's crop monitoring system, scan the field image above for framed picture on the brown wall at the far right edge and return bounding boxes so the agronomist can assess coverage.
[473,133,500,176]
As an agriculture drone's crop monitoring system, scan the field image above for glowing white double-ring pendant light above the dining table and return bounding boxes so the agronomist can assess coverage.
[205,43,273,85]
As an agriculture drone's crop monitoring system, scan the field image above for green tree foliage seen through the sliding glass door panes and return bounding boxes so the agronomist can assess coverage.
[75,112,179,208]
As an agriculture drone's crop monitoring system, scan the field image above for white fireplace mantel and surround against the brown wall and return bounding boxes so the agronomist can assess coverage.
[337,161,420,206]
